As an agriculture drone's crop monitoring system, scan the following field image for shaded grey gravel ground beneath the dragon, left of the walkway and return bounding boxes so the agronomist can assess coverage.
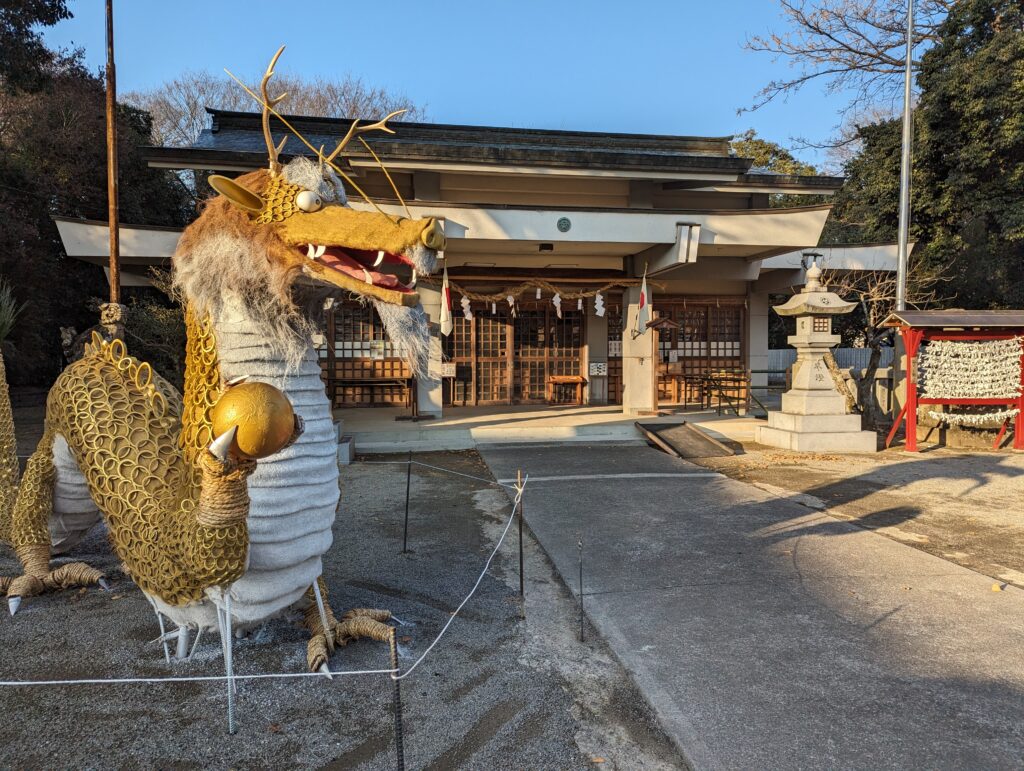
[0,444,683,769]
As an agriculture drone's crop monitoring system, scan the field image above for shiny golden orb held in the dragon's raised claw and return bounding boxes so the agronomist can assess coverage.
[210,383,295,459]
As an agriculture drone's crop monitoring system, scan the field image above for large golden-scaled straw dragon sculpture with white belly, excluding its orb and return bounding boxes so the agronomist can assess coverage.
[0,50,444,671]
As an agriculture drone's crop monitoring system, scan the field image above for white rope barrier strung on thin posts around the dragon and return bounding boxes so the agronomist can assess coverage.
[0,461,529,688]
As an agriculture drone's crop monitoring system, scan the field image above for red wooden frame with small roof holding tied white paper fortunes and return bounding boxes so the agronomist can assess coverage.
[884,310,1024,453]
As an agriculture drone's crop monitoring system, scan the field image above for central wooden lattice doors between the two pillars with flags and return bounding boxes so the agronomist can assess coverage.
[442,296,586,406]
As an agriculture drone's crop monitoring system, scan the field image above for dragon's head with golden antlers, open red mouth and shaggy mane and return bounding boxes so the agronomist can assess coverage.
[174,50,444,376]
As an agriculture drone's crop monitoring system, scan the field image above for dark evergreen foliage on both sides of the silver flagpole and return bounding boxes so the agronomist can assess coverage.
[822,0,1024,308]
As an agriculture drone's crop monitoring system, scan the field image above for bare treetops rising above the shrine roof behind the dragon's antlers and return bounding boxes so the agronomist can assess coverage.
[122,71,426,146]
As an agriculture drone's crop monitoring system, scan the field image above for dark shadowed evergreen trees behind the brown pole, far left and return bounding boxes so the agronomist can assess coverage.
[0,55,190,384]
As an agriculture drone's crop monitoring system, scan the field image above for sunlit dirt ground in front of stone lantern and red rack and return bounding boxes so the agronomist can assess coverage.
[693,443,1024,588]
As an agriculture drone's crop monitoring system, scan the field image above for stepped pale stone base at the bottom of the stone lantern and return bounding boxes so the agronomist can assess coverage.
[754,412,879,453]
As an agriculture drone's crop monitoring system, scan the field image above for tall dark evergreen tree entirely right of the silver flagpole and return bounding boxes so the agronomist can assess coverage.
[915,0,1024,308]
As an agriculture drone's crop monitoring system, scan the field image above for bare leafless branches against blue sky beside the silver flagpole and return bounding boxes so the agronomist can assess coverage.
[745,0,955,127]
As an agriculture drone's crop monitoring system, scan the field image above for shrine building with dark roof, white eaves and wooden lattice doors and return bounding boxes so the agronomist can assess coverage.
[57,110,895,414]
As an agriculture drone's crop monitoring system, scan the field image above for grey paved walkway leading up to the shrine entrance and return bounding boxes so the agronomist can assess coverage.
[479,444,1024,769]
